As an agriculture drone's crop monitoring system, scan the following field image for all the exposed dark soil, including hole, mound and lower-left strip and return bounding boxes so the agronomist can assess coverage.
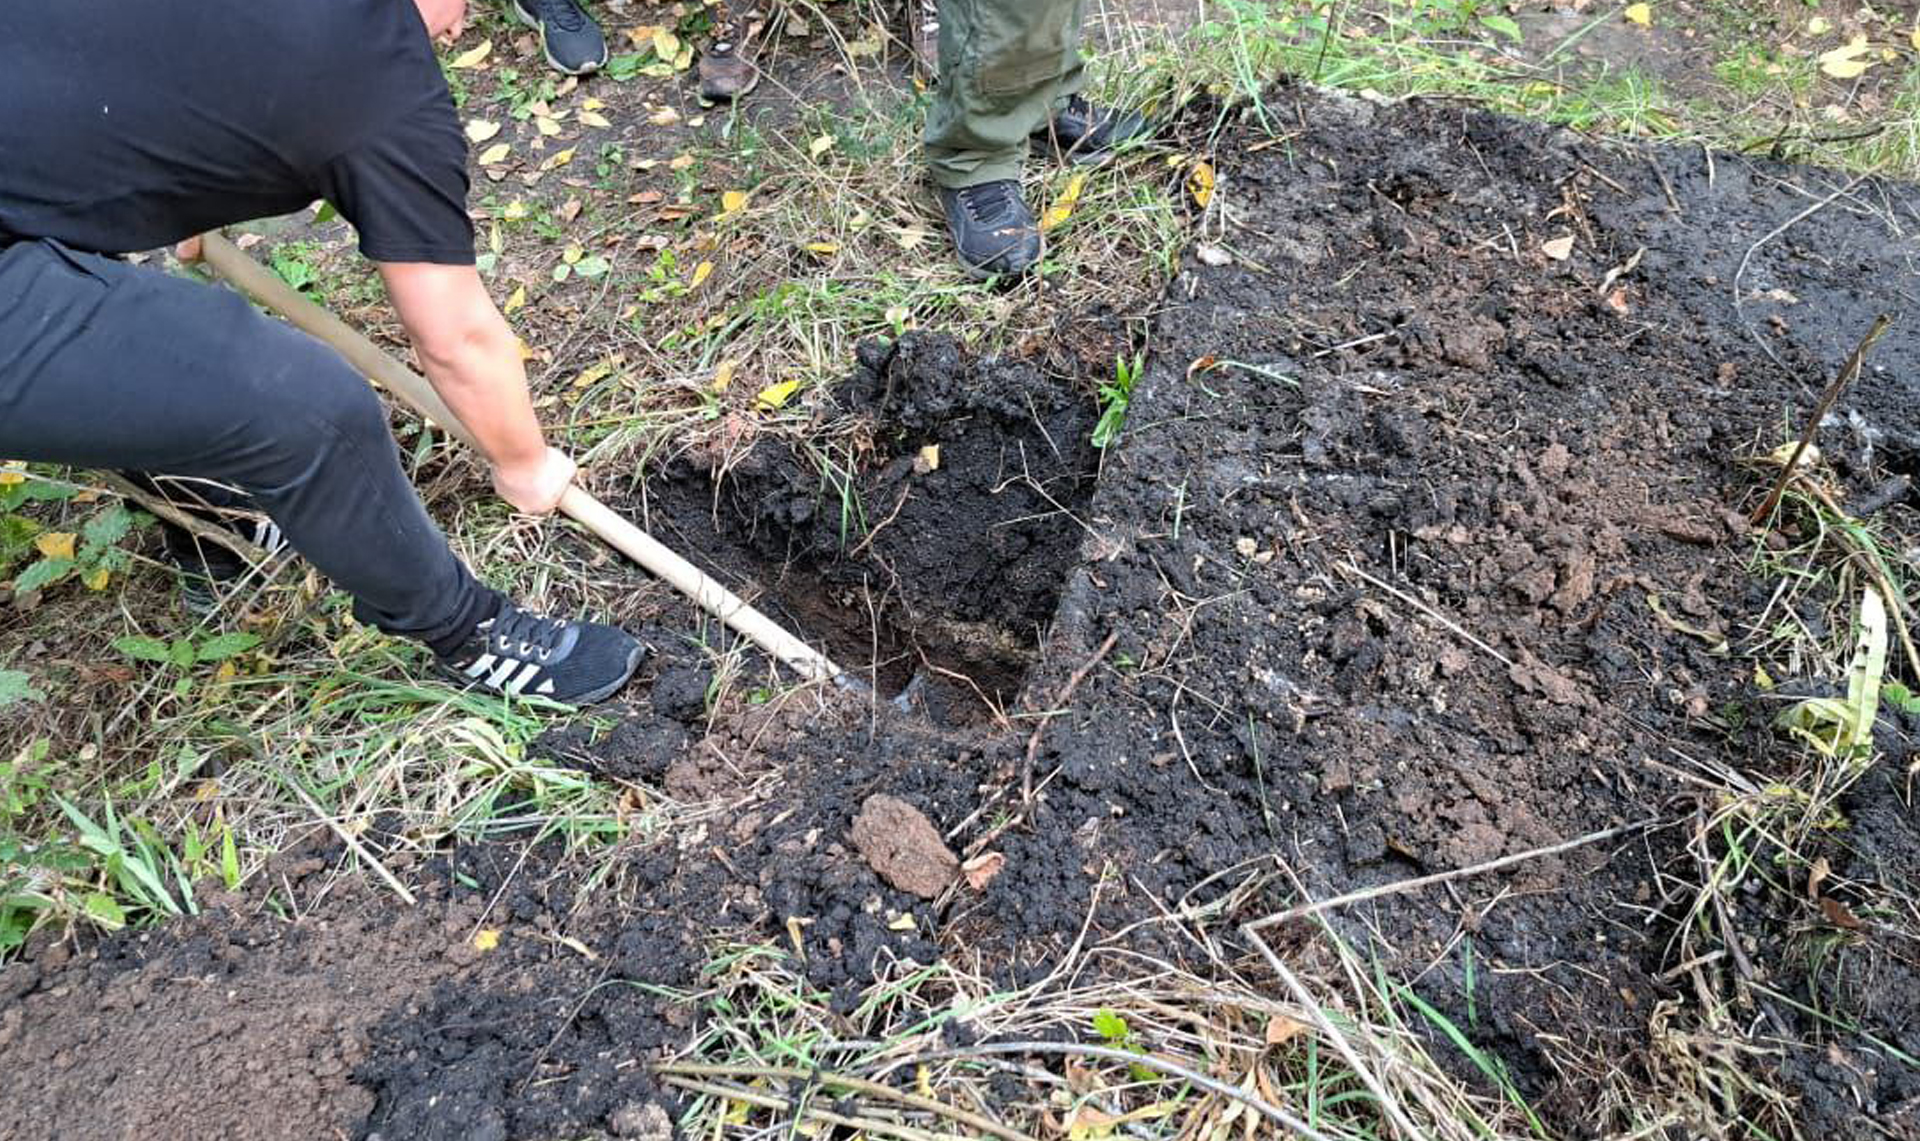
[0,88,1920,1141]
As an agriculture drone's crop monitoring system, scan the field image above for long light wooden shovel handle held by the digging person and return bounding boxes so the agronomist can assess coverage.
[202,234,848,688]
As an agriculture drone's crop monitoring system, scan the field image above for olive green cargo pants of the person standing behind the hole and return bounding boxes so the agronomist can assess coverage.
[925,0,1085,188]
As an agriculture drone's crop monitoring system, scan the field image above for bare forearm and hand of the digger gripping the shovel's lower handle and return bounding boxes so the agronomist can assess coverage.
[380,261,574,515]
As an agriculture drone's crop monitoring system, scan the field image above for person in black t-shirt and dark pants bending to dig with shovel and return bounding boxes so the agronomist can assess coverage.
[0,0,641,703]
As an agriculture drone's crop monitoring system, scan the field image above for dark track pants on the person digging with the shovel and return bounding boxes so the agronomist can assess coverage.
[0,242,497,649]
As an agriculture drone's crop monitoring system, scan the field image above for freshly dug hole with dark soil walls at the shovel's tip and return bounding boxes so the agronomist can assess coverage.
[634,332,1112,720]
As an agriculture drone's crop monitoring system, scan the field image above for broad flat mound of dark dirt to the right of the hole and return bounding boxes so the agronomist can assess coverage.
[996,84,1920,1133]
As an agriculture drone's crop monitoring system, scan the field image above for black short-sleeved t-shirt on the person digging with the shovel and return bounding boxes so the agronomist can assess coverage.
[0,0,474,265]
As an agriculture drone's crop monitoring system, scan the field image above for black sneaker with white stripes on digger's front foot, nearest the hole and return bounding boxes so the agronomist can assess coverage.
[438,599,645,705]
